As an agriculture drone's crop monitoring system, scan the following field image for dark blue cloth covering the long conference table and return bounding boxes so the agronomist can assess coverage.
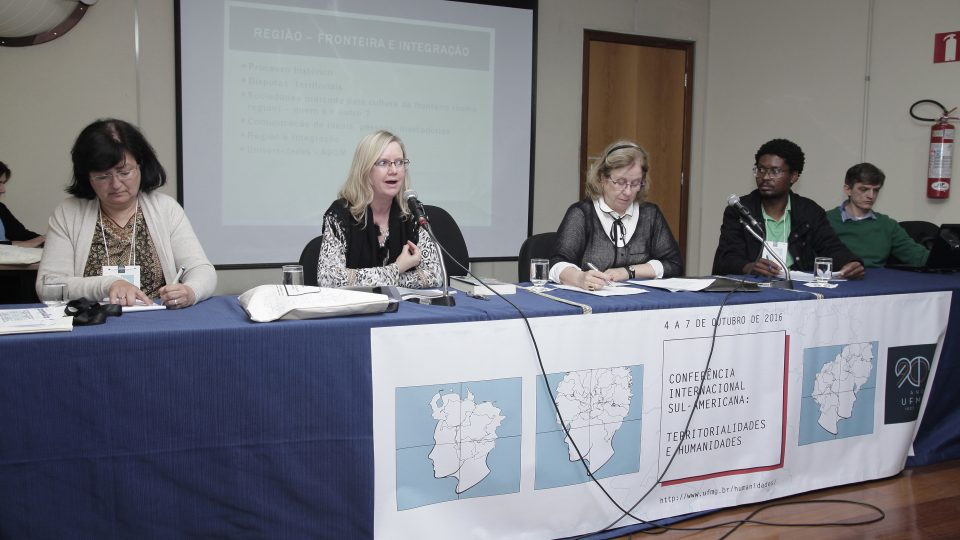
[0,269,960,538]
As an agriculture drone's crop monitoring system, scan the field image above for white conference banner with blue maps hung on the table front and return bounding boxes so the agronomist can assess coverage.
[371,293,951,538]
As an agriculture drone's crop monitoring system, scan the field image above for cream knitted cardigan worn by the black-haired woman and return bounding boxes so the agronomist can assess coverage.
[36,192,217,302]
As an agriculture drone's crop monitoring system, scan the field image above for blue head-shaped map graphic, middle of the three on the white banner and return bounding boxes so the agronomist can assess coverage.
[534,365,643,489]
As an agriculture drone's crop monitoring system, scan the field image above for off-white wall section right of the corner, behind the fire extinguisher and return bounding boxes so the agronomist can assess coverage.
[700,0,960,272]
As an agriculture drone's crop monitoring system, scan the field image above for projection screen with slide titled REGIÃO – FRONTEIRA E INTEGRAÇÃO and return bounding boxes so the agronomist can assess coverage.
[179,0,533,264]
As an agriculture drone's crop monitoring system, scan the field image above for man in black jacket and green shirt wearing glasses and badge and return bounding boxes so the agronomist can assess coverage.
[713,139,864,279]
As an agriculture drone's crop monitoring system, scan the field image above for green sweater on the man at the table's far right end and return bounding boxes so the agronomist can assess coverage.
[827,207,930,267]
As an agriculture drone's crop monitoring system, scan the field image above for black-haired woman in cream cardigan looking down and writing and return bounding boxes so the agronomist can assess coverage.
[36,119,217,309]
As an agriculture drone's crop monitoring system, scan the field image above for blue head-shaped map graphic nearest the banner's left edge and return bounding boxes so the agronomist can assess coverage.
[396,378,521,510]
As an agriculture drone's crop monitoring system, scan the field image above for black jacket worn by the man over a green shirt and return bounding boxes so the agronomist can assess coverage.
[713,190,863,275]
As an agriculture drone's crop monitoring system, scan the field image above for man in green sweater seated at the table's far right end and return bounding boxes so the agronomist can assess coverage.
[827,163,930,267]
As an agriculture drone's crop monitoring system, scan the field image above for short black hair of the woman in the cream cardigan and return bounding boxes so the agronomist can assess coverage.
[67,118,167,200]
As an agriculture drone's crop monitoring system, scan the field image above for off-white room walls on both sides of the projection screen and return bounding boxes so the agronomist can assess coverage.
[0,0,960,294]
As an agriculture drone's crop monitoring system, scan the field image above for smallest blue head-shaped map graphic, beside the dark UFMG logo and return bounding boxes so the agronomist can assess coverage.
[799,341,878,446]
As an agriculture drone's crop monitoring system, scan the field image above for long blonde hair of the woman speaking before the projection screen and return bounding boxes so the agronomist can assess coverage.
[337,130,410,222]
